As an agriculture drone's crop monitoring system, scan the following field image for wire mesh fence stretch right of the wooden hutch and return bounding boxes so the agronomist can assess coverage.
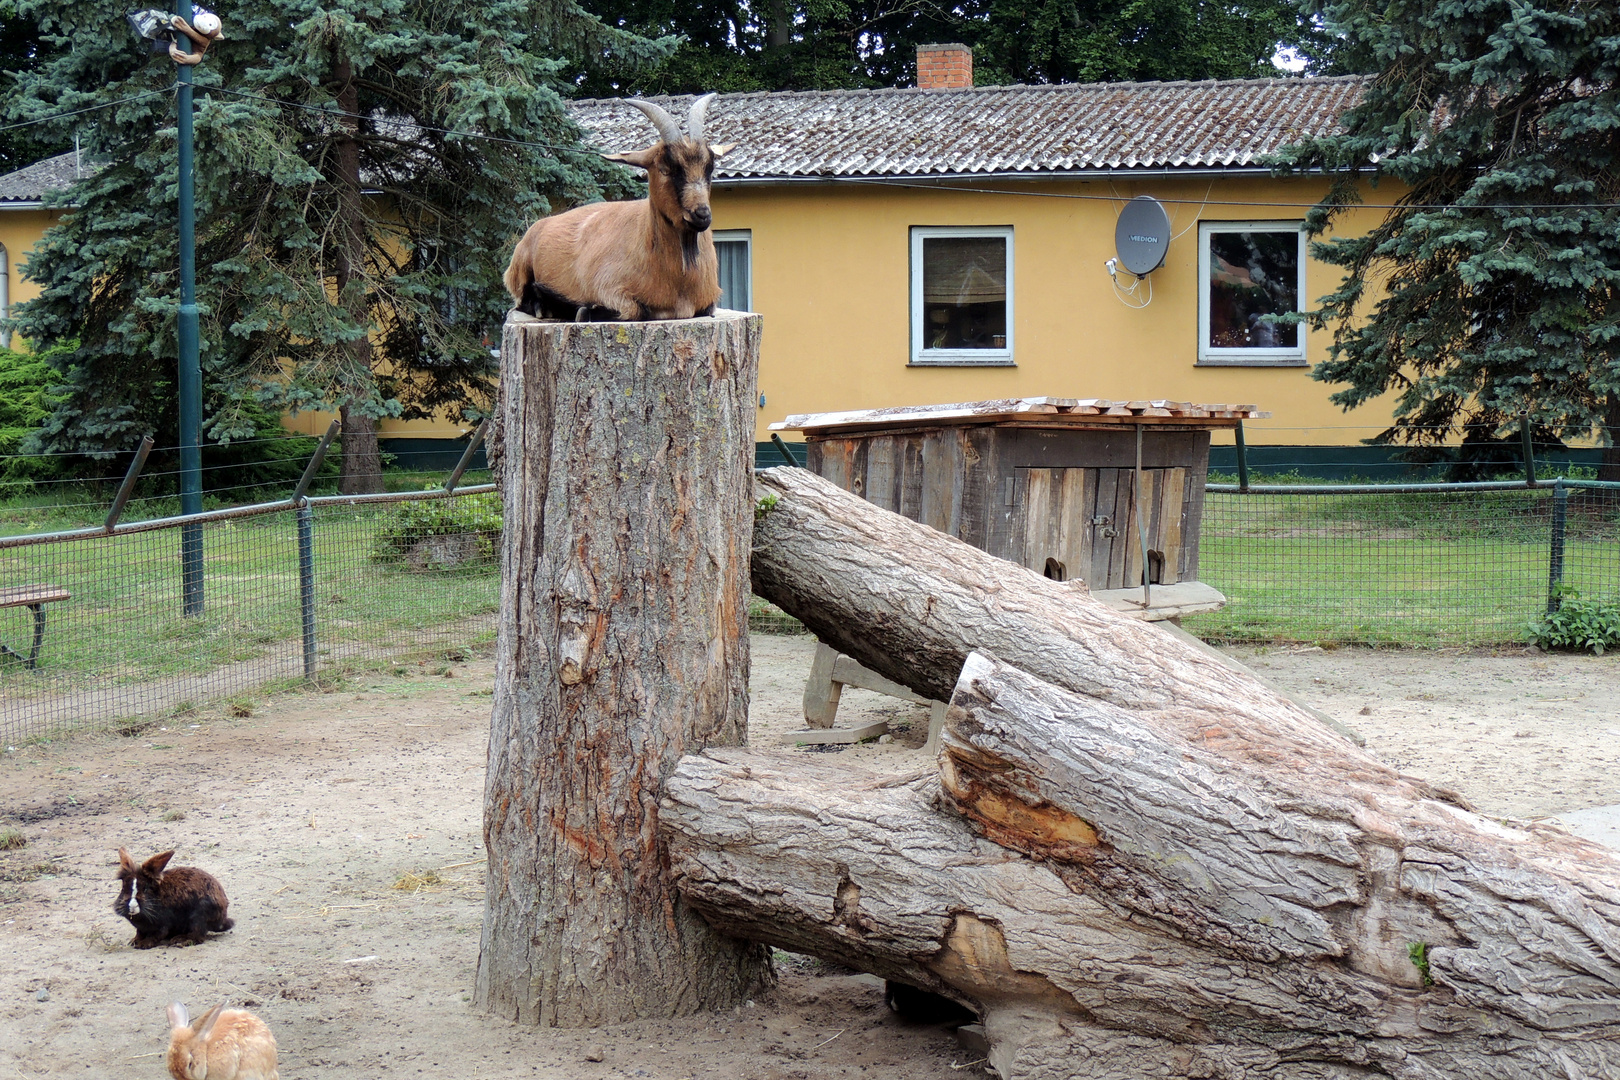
[1186,481,1620,644]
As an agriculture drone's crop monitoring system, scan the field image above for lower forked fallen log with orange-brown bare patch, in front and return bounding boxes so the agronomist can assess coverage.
[663,654,1620,1080]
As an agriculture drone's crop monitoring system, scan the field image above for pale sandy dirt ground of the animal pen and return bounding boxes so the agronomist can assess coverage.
[0,636,1620,1080]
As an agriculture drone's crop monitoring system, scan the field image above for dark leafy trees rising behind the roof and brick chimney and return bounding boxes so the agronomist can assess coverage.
[582,0,1335,96]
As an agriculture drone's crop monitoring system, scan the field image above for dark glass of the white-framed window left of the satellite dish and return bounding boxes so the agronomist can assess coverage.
[922,236,1008,350]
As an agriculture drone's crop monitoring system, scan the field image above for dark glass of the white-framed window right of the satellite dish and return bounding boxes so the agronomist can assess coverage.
[1207,228,1299,348]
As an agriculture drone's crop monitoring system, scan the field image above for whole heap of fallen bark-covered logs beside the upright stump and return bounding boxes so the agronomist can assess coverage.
[693,470,1620,1080]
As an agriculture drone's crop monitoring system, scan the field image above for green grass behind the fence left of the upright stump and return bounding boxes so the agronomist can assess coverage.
[0,507,499,698]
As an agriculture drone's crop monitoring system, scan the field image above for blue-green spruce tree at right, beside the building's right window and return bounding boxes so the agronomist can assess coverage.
[1285,0,1620,479]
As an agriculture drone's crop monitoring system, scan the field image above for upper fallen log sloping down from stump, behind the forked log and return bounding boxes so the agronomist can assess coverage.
[750,468,1399,786]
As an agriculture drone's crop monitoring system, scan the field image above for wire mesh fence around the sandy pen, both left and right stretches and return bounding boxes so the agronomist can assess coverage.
[0,469,1620,745]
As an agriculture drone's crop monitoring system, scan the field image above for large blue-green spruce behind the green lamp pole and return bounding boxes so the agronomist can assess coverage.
[8,0,674,492]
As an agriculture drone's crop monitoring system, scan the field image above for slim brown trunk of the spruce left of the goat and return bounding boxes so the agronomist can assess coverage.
[332,58,382,495]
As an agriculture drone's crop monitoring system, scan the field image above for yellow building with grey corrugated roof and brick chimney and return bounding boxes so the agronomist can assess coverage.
[572,58,1432,472]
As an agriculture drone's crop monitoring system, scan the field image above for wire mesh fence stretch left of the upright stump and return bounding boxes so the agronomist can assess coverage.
[0,486,501,745]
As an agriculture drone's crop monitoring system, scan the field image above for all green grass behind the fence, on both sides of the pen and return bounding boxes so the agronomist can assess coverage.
[0,473,1620,705]
